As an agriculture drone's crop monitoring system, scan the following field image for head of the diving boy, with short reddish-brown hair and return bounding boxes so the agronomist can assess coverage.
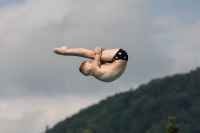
[79,60,92,76]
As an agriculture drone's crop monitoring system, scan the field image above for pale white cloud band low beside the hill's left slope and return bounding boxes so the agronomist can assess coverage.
[0,95,99,133]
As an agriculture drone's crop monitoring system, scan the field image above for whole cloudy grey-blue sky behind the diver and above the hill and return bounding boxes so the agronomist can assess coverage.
[0,0,200,133]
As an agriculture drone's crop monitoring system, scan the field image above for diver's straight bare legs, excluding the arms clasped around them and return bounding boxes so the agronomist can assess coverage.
[54,46,119,62]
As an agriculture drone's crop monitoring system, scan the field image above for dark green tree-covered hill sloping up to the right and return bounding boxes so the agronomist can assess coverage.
[46,68,200,133]
